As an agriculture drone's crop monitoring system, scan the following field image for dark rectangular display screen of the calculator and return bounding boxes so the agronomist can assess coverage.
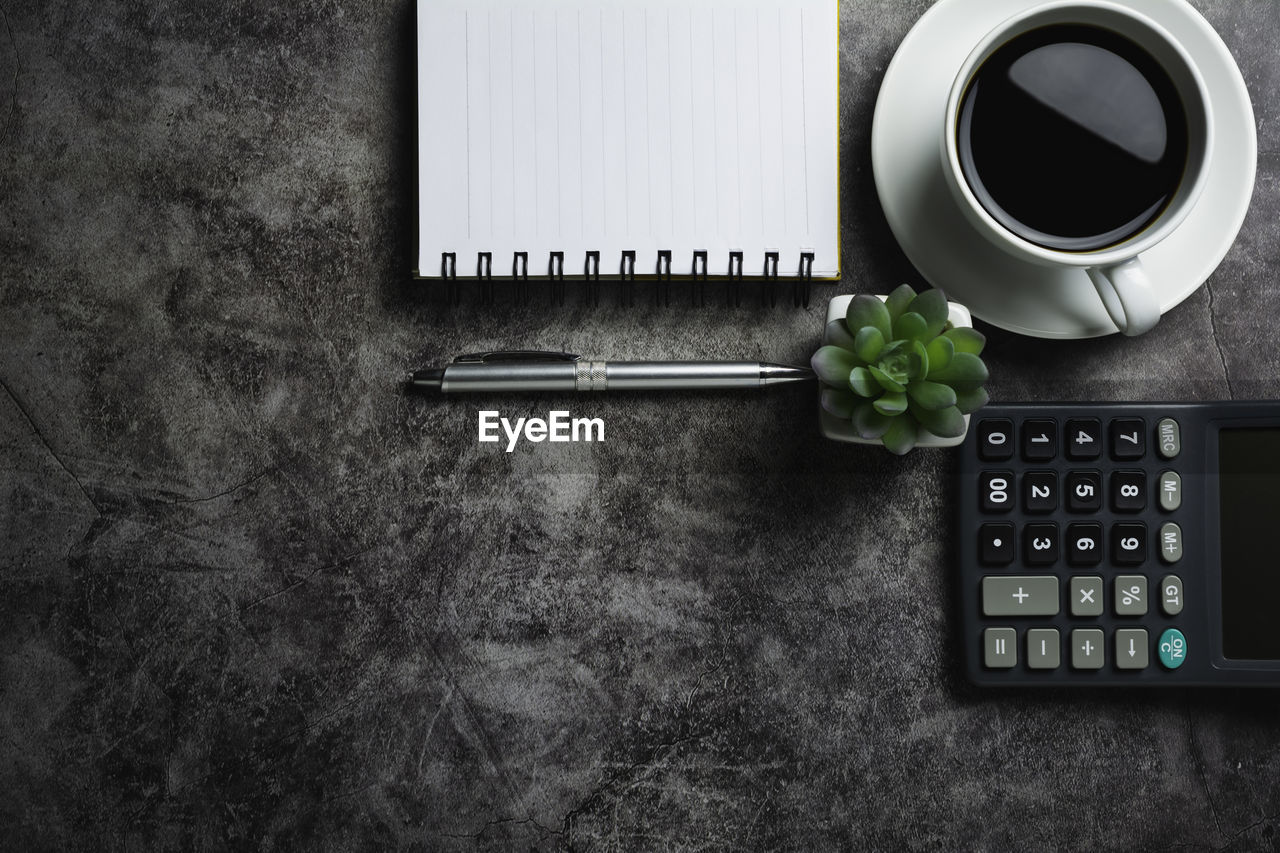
[1217,428,1280,661]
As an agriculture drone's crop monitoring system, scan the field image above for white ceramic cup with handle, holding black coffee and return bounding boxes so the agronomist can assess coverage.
[942,0,1213,334]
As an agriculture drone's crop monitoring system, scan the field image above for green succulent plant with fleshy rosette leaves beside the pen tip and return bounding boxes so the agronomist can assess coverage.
[810,284,988,455]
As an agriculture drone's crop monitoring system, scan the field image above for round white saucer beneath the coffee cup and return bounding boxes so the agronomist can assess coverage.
[872,0,1258,338]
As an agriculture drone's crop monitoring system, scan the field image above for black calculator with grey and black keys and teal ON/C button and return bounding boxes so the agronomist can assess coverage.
[957,401,1280,686]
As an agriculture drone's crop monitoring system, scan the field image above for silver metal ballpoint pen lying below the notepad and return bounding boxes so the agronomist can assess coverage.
[408,351,814,393]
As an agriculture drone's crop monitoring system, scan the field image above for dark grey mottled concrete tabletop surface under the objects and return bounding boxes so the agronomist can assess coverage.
[0,0,1280,850]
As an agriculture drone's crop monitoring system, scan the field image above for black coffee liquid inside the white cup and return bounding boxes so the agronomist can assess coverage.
[956,24,1187,251]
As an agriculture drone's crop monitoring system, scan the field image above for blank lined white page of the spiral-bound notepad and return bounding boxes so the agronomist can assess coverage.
[417,0,840,278]
